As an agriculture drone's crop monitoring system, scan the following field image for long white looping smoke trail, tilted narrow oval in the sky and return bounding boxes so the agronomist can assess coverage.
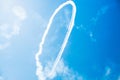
[35,0,76,80]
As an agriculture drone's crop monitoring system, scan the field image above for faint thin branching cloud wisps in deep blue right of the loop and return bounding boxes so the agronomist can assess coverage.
[76,5,110,42]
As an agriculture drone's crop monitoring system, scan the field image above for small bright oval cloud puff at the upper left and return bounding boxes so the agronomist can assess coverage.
[12,6,27,20]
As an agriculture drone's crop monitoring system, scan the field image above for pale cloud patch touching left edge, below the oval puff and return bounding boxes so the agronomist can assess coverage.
[0,24,20,50]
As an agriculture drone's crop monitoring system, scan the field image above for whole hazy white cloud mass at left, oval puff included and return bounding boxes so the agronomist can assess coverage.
[0,6,27,49]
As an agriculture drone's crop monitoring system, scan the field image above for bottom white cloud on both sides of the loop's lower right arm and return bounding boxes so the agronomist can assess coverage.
[39,60,83,80]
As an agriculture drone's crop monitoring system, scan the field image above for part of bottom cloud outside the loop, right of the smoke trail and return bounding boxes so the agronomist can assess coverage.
[51,60,83,80]
